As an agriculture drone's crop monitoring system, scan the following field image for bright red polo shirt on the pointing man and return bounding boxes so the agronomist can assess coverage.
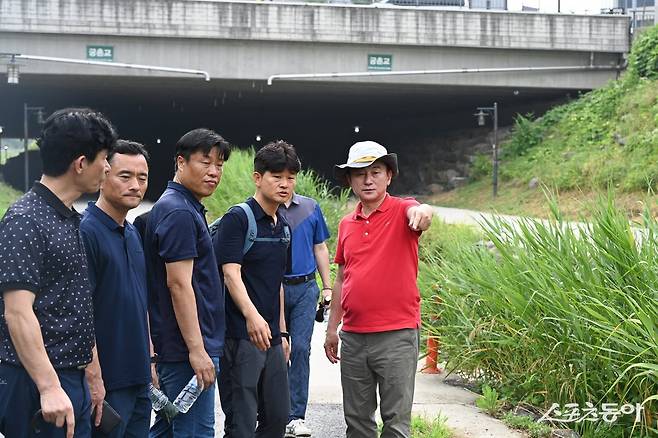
[334,194,420,333]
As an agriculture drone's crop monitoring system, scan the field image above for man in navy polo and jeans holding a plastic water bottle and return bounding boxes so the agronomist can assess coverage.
[144,128,230,437]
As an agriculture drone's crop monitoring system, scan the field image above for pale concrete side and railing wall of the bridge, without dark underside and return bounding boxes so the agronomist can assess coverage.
[0,0,629,89]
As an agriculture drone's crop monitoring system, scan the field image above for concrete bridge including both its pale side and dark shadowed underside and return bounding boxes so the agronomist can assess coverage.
[0,0,629,195]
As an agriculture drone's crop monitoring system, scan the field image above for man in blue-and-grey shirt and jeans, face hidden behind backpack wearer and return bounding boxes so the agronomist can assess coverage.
[279,193,331,438]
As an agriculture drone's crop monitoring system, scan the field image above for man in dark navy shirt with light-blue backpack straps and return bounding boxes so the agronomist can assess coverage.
[213,141,300,438]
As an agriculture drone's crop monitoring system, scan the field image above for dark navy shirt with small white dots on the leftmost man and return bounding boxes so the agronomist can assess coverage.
[0,183,94,369]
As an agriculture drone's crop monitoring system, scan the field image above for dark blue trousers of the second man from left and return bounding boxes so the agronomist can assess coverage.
[93,384,151,438]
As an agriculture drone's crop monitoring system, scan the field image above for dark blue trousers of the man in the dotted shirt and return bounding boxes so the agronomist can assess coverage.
[0,364,91,438]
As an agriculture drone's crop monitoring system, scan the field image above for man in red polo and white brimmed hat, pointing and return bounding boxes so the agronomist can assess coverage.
[324,141,433,438]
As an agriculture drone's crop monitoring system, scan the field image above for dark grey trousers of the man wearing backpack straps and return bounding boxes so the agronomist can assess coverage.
[219,339,290,438]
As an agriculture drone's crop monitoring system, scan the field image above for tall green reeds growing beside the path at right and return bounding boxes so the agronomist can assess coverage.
[421,199,658,436]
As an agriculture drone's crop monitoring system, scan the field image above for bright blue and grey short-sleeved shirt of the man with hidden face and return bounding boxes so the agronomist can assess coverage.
[279,193,329,277]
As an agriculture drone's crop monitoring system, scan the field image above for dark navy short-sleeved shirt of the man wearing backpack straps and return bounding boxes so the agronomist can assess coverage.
[214,198,288,345]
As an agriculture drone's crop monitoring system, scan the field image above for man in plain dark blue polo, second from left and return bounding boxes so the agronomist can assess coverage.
[80,140,151,438]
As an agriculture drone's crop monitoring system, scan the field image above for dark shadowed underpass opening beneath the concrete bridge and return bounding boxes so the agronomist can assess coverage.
[0,74,578,199]
